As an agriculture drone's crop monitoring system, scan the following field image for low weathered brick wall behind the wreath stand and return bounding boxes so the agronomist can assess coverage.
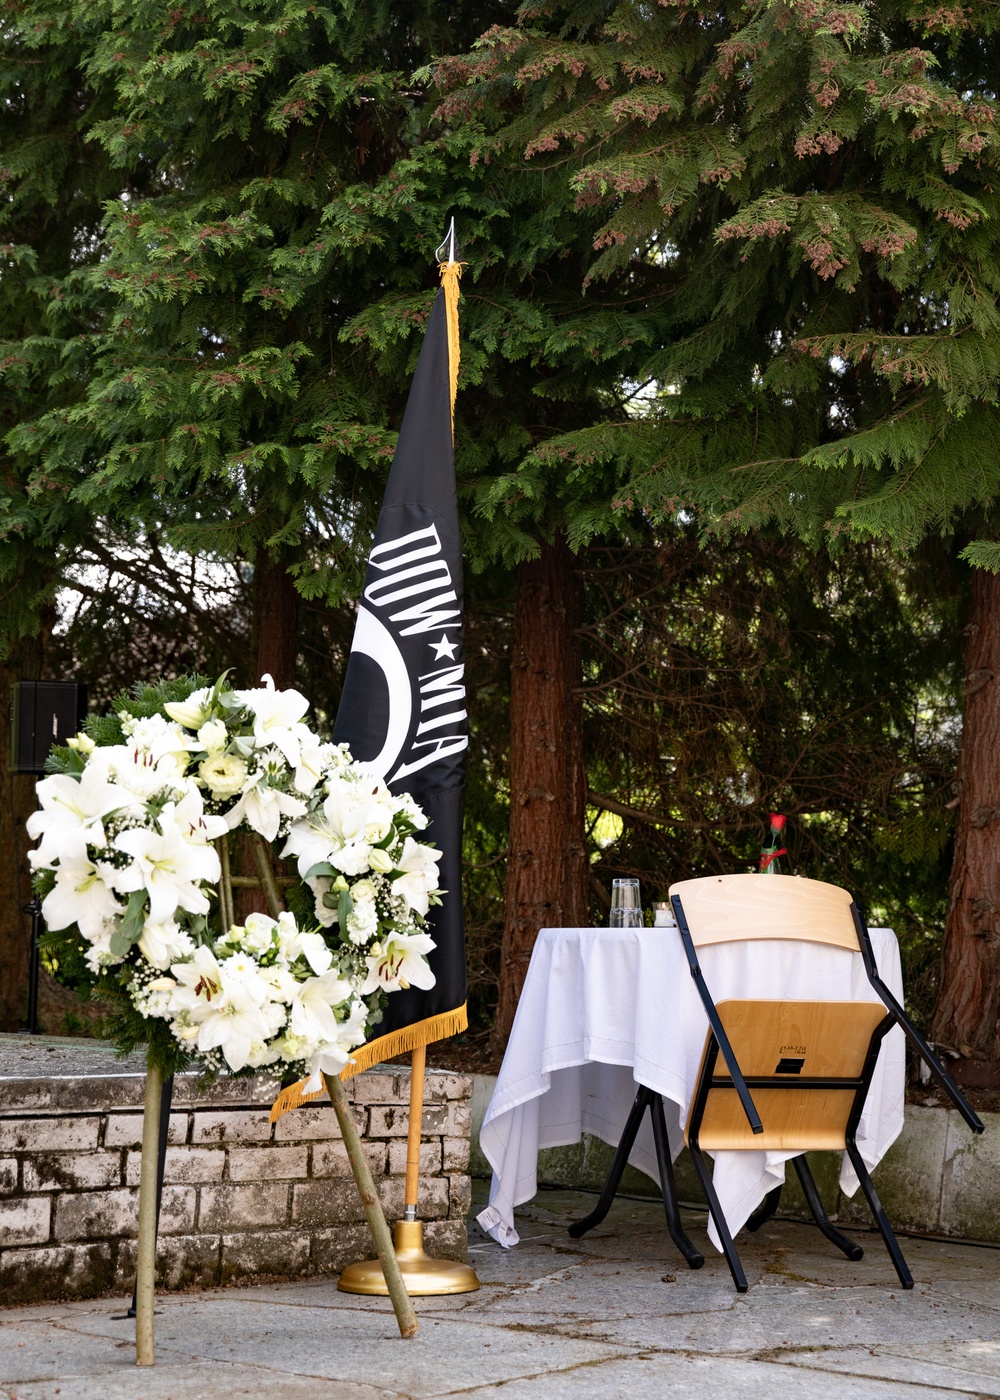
[0,1037,472,1303]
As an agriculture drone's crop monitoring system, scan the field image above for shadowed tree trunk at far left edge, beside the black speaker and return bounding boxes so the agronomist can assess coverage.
[0,637,42,1030]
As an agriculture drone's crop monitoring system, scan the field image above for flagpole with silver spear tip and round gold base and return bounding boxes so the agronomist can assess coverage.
[338,218,479,1298]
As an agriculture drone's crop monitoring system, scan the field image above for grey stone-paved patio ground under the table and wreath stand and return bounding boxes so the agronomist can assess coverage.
[0,1183,1000,1400]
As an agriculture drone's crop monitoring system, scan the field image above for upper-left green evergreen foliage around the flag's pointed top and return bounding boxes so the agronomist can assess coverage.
[0,0,680,641]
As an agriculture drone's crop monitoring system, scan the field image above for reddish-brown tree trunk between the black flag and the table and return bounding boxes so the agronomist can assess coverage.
[492,536,587,1053]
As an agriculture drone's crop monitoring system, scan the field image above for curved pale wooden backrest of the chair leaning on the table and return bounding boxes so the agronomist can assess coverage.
[669,875,860,952]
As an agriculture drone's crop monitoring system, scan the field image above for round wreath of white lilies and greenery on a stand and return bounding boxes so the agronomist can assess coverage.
[28,676,443,1091]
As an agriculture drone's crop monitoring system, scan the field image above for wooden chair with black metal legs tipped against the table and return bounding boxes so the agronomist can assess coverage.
[669,875,983,1292]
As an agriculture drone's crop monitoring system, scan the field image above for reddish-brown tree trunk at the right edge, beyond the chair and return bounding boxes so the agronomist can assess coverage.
[931,568,1000,1060]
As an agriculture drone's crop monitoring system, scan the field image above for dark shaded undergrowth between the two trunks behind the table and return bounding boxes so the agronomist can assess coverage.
[583,525,962,1015]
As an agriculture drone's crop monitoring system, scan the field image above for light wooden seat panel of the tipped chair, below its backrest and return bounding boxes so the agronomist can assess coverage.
[685,1002,887,1151]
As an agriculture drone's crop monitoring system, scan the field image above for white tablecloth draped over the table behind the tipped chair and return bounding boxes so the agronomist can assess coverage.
[479,928,905,1249]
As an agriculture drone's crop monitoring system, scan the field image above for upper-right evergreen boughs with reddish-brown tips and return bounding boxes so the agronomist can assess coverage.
[437,0,1000,567]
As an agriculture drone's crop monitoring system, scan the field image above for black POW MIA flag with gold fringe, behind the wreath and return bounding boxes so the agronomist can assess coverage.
[333,270,469,1074]
